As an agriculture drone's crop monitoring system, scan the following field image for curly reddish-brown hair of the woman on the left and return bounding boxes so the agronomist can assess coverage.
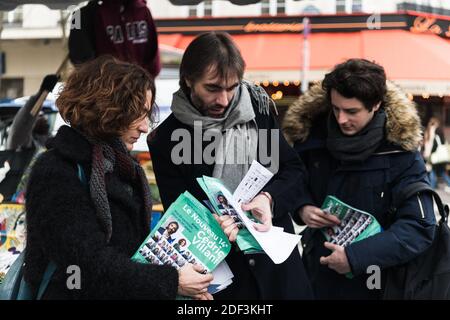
[56,56,157,139]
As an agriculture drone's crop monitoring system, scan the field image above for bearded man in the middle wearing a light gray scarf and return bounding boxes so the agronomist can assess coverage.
[148,32,312,299]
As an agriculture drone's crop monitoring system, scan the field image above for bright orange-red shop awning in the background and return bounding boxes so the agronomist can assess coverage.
[159,30,450,95]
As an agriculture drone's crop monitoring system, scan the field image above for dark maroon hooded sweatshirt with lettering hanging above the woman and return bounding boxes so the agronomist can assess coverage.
[69,0,161,77]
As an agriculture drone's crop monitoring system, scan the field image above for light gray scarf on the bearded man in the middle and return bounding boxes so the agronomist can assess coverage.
[172,82,270,192]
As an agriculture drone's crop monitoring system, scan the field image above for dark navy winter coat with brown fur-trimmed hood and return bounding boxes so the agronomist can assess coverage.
[283,85,435,299]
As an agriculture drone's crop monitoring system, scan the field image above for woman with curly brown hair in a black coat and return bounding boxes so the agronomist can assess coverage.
[25,57,212,299]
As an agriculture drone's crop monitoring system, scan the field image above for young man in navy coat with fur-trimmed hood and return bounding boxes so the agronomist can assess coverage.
[283,59,435,299]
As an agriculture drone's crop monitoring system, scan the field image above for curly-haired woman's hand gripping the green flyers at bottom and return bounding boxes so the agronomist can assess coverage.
[178,263,214,300]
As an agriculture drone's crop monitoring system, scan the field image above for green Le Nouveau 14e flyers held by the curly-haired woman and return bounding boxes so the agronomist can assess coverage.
[132,191,233,293]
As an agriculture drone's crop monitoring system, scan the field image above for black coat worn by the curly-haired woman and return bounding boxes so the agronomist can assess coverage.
[25,126,178,299]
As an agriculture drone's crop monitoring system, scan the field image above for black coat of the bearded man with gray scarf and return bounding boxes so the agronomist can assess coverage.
[148,104,312,299]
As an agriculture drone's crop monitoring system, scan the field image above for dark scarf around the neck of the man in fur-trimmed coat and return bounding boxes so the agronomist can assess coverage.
[327,109,386,162]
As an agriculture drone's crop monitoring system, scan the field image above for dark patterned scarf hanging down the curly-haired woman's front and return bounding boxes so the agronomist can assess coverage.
[85,136,152,242]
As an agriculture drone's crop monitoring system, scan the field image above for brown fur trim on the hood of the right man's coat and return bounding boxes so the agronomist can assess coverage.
[282,82,422,151]
